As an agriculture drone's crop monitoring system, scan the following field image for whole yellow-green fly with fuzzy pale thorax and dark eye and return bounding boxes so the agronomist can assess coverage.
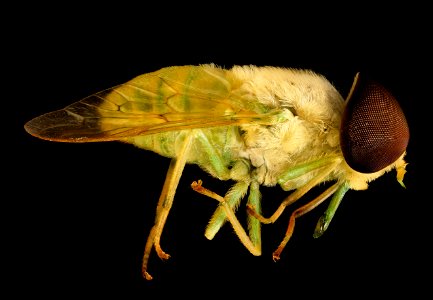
[25,64,409,280]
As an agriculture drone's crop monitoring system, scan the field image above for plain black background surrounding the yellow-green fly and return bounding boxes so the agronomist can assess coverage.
[6,3,431,299]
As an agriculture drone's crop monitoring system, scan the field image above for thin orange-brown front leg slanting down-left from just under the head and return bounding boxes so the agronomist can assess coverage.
[272,182,341,261]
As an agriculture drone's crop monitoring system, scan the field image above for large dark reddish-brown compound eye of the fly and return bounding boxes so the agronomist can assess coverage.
[340,73,409,173]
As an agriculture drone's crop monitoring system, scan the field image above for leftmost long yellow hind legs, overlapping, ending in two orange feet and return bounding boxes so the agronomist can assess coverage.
[142,132,193,280]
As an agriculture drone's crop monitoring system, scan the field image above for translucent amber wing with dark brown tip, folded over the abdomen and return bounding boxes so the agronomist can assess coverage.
[25,65,272,142]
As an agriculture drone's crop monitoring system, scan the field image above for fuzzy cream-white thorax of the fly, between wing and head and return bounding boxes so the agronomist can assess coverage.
[228,66,344,186]
